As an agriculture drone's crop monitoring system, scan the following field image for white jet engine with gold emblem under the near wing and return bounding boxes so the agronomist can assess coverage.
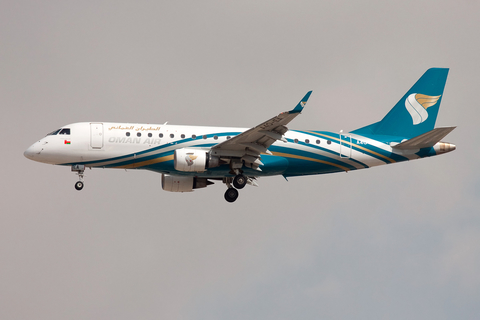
[173,148,220,172]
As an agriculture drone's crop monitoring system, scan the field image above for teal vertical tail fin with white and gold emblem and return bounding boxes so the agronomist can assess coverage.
[352,68,448,139]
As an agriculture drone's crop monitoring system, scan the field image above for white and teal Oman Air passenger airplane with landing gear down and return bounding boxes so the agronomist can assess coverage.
[24,68,456,202]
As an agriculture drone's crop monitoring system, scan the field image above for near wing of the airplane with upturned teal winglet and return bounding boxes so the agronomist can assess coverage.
[211,91,312,171]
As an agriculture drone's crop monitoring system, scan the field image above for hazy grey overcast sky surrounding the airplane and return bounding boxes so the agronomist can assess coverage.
[0,0,480,320]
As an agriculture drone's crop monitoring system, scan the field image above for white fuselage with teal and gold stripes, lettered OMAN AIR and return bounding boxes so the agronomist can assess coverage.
[25,122,450,179]
